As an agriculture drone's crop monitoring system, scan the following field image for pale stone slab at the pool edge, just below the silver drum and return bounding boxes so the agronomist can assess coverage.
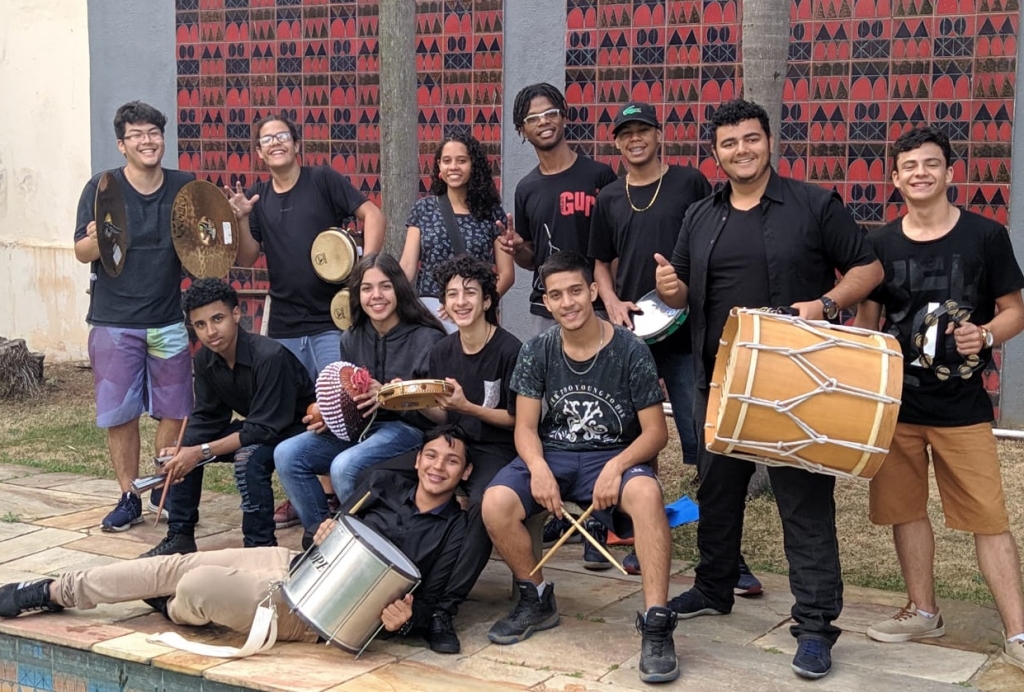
[203,643,394,692]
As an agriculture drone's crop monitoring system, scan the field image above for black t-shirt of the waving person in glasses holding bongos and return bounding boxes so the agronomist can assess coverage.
[246,166,367,339]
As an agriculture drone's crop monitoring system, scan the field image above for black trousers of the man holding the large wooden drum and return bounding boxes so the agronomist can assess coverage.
[693,389,843,644]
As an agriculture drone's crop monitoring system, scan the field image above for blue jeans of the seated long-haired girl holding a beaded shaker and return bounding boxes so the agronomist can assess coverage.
[273,421,423,530]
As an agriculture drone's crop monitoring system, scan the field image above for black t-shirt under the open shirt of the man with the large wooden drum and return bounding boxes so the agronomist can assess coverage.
[703,207,771,373]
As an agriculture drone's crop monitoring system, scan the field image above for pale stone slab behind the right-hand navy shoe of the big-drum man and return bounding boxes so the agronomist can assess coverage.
[755,630,988,683]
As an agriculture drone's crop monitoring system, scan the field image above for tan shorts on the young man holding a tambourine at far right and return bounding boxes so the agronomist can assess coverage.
[870,423,1010,534]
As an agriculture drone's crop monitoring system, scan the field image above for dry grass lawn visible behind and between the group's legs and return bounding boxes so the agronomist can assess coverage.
[8,364,1024,603]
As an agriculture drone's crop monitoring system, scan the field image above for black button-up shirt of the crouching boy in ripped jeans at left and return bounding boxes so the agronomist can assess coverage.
[186,329,316,446]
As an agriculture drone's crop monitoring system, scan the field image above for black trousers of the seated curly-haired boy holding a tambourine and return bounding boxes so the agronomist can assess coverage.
[362,442,516,615]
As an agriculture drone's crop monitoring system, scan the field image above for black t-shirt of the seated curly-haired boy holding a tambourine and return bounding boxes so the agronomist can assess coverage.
[430,327,522,446]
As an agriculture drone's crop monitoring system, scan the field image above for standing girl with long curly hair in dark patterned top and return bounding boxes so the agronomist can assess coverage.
[401,132,515,330]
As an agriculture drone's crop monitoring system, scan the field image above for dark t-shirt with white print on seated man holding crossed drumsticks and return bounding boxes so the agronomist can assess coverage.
[512,326,664,451]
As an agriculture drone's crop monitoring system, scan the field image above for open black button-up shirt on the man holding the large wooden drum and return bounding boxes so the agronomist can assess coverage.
[672,169,874,388]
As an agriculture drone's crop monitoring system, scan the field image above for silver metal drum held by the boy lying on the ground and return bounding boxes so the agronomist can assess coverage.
[281,516,420,653]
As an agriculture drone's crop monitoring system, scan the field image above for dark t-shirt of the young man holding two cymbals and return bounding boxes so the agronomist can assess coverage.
[75,168,196,329]
